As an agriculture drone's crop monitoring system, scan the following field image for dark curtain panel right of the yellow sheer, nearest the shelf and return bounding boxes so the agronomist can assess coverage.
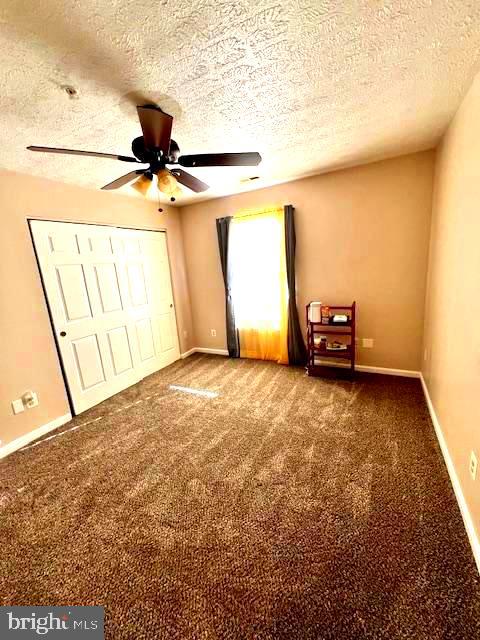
[284,204,307,365]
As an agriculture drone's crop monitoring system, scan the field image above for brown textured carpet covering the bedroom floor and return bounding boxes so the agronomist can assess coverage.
[0,355,480,640]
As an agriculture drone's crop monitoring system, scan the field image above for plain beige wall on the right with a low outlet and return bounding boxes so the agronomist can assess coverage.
[423,76,480,536]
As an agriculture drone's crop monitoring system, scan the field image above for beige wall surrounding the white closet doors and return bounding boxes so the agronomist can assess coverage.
[0,172,193,445]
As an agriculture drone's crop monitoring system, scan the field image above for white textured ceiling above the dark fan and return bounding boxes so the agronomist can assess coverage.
[0,0,480,204]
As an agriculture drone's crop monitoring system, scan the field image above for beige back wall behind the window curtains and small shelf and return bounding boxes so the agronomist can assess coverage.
[182,151,434,370]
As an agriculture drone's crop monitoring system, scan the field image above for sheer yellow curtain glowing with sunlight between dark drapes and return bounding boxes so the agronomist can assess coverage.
[229,207,288,364]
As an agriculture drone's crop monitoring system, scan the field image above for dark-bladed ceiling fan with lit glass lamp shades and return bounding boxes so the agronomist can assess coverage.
[27,104,262,202]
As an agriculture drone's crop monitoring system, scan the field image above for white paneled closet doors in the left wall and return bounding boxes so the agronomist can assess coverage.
[30,220,180,413]
